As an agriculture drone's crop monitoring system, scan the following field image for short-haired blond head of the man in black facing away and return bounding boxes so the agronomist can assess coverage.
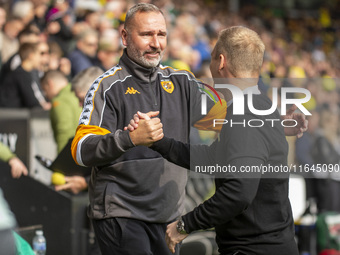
[213,26,265,78]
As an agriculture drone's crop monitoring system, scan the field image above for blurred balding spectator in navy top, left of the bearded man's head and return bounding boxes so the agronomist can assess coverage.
[68,29,99,77]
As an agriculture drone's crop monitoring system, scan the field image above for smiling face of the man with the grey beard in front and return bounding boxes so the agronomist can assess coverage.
[122,12,167,68]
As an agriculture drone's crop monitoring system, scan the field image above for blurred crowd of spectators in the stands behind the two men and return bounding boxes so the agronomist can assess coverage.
[0,0,340,210]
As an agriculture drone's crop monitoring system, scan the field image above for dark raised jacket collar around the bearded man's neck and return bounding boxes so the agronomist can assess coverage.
[119,49,159,82]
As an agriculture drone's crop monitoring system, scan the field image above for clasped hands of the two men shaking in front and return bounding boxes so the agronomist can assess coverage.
[124,111,164,147]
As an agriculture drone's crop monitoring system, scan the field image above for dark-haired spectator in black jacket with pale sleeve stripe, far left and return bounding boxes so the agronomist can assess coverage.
[1,43,51,110]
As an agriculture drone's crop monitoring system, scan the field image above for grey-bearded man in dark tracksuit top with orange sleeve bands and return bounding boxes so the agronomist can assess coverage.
[72,3,225,255]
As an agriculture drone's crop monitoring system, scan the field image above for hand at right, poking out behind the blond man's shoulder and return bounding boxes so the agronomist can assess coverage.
[281,105,308,138]
